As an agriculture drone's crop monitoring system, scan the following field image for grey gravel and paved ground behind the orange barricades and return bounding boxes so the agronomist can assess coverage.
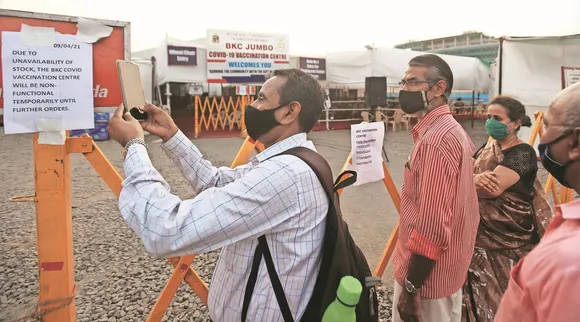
[0,122,508,321]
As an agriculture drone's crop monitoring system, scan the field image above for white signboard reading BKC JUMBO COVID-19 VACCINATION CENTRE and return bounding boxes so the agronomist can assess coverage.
[207,30,290,84]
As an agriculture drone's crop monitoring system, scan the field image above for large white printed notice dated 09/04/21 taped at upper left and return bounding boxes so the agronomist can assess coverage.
[2,31,95,134]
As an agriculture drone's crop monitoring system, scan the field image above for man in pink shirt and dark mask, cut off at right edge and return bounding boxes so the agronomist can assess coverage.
[494,83,580,322]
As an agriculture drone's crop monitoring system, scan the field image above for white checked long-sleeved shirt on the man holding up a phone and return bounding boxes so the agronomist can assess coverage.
[119,132,328,322]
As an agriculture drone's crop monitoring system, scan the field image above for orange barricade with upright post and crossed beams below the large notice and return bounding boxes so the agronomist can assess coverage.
[34,134,220,322]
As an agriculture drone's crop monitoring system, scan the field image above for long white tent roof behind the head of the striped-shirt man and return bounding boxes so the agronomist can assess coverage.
[326,48,490,92]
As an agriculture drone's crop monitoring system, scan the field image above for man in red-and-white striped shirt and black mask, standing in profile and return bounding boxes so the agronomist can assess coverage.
[393,54,479,322]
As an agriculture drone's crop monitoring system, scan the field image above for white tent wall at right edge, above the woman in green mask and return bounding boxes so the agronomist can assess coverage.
[490,35,580,142]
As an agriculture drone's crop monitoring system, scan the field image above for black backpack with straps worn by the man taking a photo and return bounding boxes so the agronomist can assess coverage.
[242,147,380,322]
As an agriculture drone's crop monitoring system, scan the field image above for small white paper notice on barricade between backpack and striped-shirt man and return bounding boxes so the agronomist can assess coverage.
[350,122,385,186]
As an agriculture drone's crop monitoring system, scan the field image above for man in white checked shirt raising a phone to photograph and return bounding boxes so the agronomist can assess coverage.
[109,69,329,321]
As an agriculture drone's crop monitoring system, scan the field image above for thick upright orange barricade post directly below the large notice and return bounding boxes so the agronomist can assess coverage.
[33,133,75,322]
